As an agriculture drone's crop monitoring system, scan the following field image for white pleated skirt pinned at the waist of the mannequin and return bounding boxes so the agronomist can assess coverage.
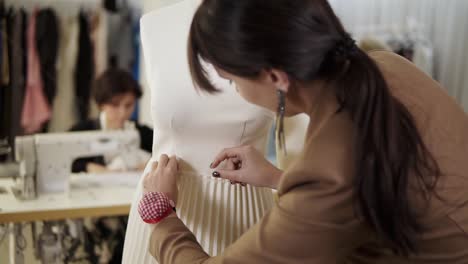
[122,173,274,264]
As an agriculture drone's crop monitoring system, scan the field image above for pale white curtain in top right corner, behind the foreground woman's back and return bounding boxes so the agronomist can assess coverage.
[330,0,468,111]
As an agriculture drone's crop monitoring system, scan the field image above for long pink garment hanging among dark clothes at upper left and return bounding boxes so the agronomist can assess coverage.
[21,10,51,134]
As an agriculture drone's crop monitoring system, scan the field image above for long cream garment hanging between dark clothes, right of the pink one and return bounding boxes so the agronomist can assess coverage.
[49,15,79,132]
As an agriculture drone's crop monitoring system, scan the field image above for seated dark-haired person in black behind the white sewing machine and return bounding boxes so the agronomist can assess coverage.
[71,68,153,173]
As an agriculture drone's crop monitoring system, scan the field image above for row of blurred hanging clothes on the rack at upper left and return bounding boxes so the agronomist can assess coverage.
[0,0,143,138]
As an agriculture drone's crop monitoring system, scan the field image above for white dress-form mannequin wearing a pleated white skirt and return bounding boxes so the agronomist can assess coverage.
[122,0,274,264]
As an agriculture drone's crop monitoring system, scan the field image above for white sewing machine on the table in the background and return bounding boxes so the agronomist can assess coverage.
[12,130,140,200]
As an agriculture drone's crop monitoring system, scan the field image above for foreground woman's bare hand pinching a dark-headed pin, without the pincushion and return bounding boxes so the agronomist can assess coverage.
[211,146,283,189]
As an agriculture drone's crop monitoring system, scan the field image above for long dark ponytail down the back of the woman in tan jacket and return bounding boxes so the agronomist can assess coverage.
[336,48,440,255]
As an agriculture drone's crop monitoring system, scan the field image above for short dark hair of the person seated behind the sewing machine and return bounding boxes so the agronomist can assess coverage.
[93,68,143,105]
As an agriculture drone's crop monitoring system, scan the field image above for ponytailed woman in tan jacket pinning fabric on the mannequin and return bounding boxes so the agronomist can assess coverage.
[142,0,468,264]
